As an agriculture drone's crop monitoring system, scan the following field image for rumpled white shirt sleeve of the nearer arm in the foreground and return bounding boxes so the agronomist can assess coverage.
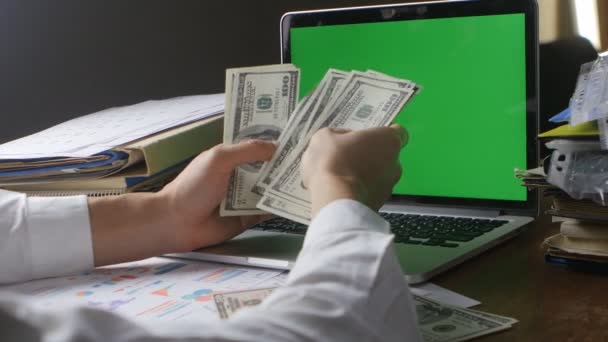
[0,200,420,342]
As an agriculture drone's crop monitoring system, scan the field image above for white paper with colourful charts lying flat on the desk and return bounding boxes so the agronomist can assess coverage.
[0,258,286,322]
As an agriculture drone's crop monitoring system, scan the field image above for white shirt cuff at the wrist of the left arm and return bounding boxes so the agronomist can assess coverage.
[27,196,94,278]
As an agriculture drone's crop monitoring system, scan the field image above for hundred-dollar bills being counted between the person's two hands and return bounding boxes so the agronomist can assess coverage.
[221,65,418,224]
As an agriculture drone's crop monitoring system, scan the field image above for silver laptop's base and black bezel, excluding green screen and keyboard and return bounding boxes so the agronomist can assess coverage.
[169,0,538,283]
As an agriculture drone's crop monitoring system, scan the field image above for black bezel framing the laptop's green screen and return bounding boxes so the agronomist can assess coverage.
[281,0,539,215]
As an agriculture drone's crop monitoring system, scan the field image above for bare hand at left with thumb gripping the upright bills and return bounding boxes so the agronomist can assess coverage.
[159,140,275,251]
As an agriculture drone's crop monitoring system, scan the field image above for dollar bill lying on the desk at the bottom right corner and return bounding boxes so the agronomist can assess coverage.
[414,296,511,342]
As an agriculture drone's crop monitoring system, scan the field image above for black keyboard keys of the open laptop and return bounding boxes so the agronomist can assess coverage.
[251,213,509,248]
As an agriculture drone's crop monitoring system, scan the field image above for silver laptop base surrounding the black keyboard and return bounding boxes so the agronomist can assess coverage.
[168,204,533,284]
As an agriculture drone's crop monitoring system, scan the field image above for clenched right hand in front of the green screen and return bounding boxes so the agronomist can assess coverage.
[302,124,408,217]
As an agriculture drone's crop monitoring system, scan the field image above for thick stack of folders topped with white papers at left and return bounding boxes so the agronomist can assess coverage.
[0,94,224,196]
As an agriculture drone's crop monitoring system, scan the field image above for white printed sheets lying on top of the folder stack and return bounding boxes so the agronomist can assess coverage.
[0,94,224,159]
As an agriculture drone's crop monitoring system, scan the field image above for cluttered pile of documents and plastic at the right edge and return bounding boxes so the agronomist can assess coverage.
[516,54,608,271]
